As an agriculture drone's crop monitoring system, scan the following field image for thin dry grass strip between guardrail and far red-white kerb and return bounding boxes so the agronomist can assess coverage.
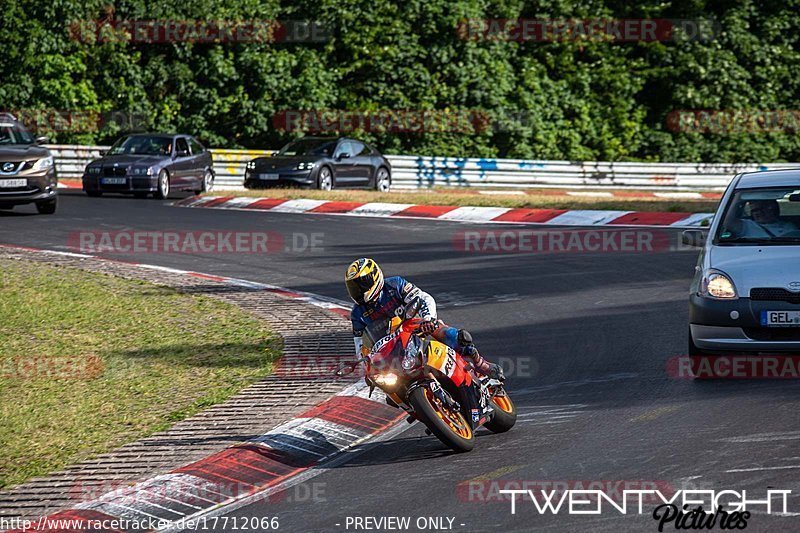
[212,188,718,213]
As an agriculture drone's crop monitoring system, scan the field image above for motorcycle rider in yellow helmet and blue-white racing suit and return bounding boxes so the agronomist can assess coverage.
[345,257,505,379]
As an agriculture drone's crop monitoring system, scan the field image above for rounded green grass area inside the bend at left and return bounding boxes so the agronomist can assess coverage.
[0,260,281,487]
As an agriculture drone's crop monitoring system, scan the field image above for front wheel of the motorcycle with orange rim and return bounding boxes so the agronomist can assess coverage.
[408,387,475,452]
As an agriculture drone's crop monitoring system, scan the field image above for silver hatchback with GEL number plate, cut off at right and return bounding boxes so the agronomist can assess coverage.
[682,170,800,355]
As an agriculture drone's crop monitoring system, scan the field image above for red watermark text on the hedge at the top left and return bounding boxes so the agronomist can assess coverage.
[69,19,331,44]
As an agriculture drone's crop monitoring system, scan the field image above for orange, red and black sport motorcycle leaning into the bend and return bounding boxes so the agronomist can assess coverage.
[335,302,517,452]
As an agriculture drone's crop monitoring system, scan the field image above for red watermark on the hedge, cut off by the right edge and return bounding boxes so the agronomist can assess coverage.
[666,109,800,135]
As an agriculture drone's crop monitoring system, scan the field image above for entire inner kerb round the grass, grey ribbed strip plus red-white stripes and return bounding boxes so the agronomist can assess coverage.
[0,245,404,533]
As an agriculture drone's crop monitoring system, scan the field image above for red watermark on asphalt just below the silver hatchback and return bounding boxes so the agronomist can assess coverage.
[666,354,800,379]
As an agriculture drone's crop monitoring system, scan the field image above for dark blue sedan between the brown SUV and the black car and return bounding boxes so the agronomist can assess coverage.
[83,133,214,199]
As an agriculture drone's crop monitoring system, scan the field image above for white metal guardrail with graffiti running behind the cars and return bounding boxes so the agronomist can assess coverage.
[48,145,800,191]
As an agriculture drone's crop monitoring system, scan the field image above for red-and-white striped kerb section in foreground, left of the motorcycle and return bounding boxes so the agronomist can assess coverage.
[11,383,403,533]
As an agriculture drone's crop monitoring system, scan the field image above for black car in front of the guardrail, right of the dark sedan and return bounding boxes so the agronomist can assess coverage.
[244,137,392,192]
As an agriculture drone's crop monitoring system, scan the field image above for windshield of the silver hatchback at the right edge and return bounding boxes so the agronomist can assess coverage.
[716,187,800,245]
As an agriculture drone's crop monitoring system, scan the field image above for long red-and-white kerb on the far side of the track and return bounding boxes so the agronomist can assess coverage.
[173,196,714,228]
